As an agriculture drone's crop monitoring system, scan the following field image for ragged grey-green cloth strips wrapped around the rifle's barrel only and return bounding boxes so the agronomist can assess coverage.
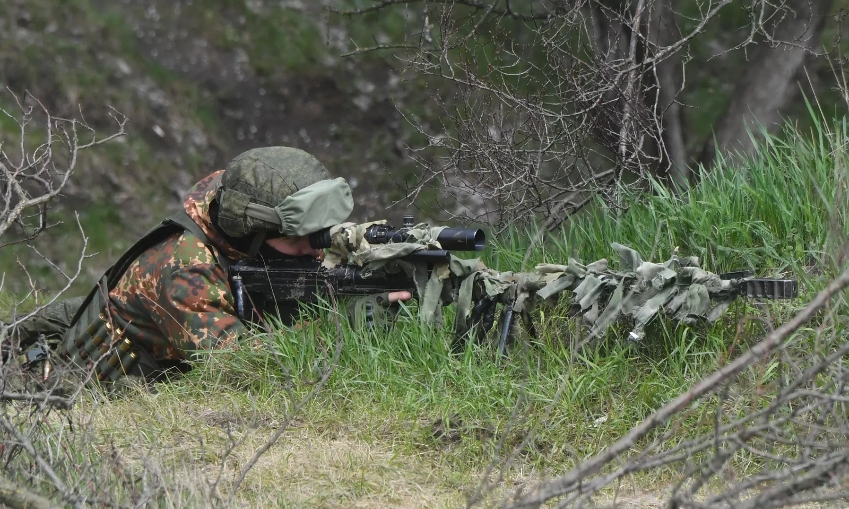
[438,243,735,340]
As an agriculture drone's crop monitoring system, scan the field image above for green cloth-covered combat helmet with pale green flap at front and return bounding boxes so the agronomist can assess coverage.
[216,147,354,256]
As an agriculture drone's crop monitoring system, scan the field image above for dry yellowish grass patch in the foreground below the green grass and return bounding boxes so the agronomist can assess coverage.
[77,388,465,508]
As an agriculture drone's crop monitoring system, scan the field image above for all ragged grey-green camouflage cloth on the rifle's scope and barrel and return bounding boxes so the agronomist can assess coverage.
[318,223,736,340]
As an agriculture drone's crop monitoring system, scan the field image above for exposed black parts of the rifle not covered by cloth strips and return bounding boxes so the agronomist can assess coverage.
[225,217,798,346]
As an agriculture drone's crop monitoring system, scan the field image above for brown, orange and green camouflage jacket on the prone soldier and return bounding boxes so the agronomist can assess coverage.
[109,171,247,361]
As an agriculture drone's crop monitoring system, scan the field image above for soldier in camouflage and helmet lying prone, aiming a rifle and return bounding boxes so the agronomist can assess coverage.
[16,147,411,380]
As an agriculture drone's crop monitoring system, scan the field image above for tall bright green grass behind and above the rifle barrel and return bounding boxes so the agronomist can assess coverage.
[534,105,847,280]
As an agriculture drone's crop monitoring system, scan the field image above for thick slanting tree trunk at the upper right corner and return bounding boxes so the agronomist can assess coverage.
[699,0,833,166]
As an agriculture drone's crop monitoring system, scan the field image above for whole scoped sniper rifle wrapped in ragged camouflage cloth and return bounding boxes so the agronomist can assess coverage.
[230,216,798,354]
